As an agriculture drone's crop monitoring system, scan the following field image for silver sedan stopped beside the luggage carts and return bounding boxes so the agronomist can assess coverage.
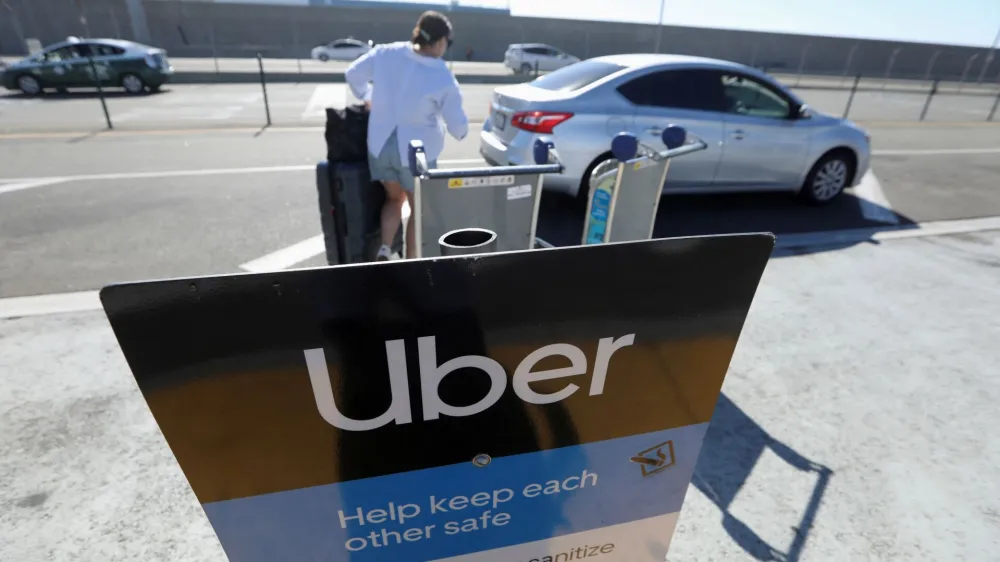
[480,55,871,203]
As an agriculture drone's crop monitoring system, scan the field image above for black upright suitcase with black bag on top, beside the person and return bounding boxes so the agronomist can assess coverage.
[316,106,403,265]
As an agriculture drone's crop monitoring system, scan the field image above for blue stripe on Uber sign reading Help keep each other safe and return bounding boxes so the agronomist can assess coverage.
[204,424,708,562]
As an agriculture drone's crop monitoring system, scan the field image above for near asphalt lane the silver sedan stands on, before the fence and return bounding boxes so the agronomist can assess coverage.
[0,115,1000,297]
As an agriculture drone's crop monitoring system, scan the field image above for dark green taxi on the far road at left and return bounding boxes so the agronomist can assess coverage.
[0,37,174,96]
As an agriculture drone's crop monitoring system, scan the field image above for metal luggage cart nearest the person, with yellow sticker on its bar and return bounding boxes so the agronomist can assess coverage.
[408,139,563,258]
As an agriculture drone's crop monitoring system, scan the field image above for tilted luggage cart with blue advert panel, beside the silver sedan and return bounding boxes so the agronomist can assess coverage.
[581,125,708,245]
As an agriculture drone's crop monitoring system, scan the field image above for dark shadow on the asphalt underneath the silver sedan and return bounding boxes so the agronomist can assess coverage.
[538,192,916,257]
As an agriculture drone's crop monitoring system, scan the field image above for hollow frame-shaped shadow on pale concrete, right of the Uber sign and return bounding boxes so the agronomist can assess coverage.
[692,394,833,562]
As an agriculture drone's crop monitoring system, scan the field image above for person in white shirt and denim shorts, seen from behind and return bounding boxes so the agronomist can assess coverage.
[344,11,469,261]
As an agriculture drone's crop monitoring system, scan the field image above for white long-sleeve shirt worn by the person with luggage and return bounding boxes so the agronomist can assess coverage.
[344,41,469,165]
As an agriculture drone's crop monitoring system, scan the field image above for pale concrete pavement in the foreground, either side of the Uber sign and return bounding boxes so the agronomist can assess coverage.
[0,232,1000,562]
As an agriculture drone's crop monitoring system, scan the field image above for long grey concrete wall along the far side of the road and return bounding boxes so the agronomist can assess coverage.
[7,0,1000,82]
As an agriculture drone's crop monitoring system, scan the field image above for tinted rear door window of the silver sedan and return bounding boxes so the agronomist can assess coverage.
[618,69,723,111]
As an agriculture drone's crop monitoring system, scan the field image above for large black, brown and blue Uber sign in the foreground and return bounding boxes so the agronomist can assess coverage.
[101,234,774,562]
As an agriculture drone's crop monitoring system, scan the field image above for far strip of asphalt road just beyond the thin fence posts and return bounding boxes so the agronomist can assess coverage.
[0,78,1000,134]
